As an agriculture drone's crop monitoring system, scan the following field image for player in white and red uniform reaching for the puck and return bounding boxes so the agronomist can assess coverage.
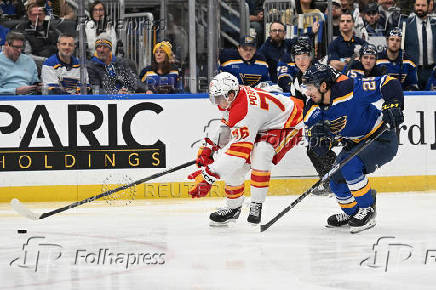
[188,72,303,225]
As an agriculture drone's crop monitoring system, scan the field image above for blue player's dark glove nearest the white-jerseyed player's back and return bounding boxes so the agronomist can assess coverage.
[306,121,335,157]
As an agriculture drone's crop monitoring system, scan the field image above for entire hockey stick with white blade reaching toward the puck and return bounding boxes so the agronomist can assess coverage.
[11,160,195,220]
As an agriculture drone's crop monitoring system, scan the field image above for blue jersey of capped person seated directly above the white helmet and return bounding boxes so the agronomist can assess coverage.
[218,49,270,87]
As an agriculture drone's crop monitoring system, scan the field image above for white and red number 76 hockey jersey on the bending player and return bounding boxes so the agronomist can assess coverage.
[210,86,304,177]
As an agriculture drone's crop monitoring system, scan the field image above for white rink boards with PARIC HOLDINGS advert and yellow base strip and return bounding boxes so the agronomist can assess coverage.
[0,92,436,202]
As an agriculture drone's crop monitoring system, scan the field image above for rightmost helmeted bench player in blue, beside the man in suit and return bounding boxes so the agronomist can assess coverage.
[377,27,418,91]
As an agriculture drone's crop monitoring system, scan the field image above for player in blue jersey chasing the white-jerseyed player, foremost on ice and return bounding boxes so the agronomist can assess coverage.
[303,64,404,233]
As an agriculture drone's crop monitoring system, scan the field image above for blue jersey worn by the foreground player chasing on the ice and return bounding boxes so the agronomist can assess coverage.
[304,76,404,142]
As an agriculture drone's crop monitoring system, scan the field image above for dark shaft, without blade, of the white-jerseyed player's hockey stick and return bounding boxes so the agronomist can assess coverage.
[14,160,195,219]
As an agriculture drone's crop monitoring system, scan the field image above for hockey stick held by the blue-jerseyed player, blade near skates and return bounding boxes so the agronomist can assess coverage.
[260,125,388,232]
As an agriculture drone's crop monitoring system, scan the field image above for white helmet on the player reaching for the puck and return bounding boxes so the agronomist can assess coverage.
[209,72,239,108]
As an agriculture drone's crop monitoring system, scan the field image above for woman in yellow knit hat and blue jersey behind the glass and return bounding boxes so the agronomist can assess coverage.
[139,41,183,94]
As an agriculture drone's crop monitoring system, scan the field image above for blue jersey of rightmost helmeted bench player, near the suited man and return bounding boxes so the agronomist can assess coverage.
[376,49,418,90]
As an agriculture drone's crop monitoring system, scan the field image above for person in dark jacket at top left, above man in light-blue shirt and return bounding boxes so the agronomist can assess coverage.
[15,3,61,66]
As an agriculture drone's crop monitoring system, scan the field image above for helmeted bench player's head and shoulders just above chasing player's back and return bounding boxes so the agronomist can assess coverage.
[343,44,386,79]
